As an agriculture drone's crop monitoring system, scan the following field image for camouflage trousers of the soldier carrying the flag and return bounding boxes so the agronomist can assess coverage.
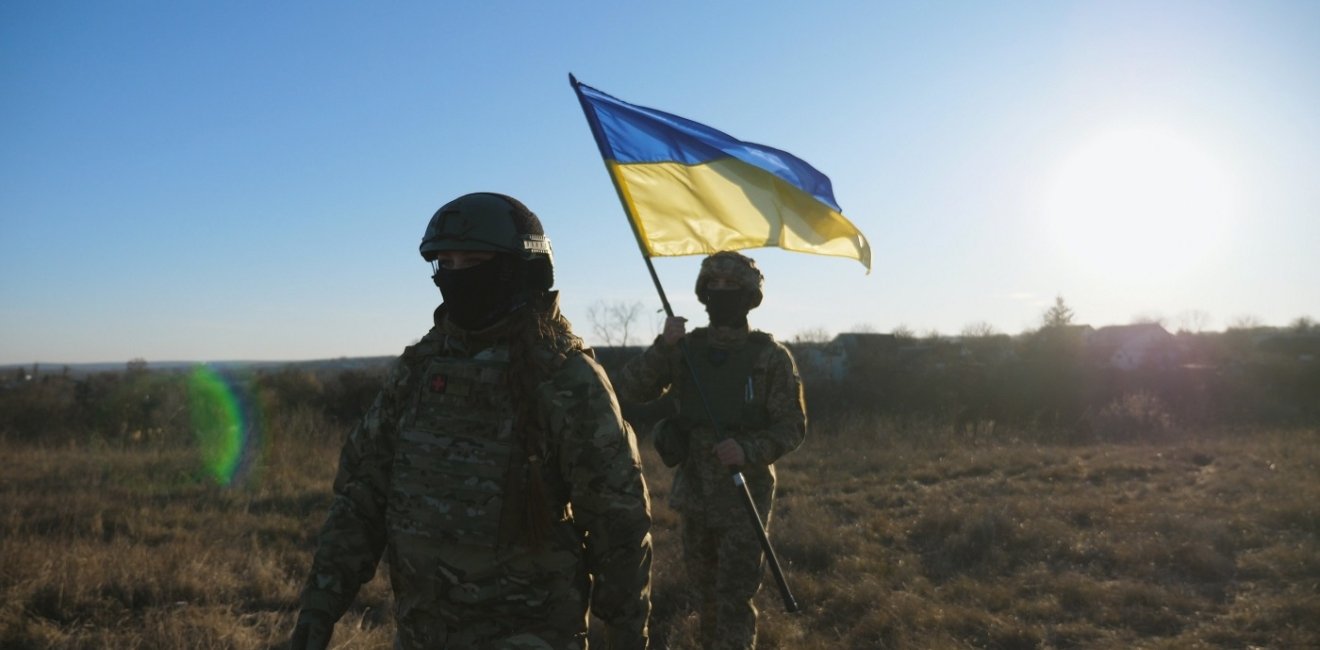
[682,509,770,650]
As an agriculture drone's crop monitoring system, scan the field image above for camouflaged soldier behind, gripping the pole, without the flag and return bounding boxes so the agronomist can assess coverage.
[616,251,807,650]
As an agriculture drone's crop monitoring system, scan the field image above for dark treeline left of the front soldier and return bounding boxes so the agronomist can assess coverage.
[0,359,385,444]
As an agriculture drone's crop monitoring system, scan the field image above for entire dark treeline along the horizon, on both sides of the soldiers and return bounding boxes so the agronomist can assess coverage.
[0,325,1320,443]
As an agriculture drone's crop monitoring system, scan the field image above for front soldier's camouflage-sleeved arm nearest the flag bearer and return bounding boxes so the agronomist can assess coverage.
[546,354,651,650]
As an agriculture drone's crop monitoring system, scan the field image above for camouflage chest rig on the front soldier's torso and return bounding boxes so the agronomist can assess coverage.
[388,346,523,548]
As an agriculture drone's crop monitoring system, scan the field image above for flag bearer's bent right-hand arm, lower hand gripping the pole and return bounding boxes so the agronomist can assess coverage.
[734,343,807,465]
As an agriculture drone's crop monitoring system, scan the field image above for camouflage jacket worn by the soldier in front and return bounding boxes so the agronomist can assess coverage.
[301,297,651,650]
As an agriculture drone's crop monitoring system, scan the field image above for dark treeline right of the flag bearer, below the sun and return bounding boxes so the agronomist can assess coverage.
[797,325,1320,440]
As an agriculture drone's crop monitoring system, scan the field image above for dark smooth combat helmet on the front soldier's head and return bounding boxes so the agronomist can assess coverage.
[418,192,554,291]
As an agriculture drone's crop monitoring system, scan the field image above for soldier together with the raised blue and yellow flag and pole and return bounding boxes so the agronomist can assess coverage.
[569,74,871,649]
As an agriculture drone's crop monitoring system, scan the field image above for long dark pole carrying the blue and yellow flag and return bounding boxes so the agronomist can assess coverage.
[569,73,800,613]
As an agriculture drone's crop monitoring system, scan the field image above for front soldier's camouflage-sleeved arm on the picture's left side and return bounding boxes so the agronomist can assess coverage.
[300,359,407,622]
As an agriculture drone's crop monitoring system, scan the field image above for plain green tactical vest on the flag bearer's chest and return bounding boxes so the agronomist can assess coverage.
[677,330,771,435]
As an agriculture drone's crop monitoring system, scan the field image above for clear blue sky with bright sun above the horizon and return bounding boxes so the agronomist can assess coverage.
[0,0,1320,363]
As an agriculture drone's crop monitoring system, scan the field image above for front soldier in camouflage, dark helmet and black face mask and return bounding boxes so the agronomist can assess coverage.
[292,193,651,650]
